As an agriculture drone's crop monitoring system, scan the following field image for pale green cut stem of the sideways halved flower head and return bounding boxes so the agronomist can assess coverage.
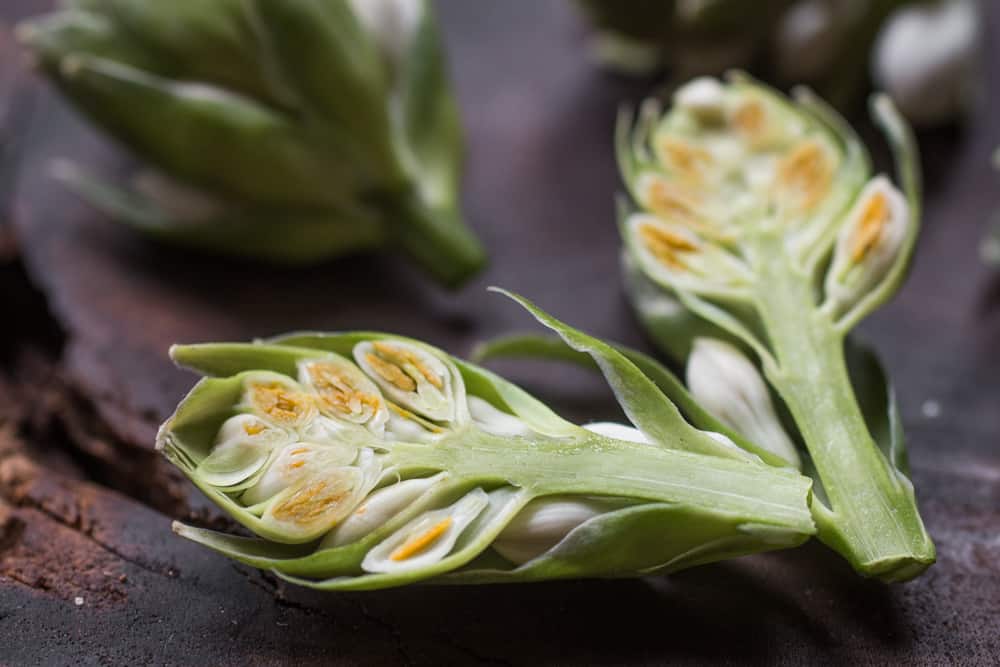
[390,429,815,534]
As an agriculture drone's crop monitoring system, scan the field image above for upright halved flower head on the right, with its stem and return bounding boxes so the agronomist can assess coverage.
[618,76,935,580]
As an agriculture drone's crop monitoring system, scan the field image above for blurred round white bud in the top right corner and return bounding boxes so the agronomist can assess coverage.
[872,0,982,125]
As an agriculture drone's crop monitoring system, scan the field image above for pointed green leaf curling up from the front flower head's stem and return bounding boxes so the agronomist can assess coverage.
[490,287,747,458]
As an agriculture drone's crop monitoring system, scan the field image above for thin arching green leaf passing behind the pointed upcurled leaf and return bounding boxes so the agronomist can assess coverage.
[472,334,787,467]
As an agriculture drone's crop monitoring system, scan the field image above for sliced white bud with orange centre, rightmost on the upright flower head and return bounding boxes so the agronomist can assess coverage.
[825,176,910,314]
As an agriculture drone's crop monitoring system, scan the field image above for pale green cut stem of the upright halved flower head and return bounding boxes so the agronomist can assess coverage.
[754,232,935,580]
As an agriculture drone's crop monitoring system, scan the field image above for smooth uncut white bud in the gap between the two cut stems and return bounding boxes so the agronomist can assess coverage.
[687,338,802,468]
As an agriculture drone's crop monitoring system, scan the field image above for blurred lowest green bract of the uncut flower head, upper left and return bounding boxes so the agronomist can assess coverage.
[50,163,385,265]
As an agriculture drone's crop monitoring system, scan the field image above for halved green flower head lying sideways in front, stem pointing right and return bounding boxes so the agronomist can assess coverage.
[157,290,814,590]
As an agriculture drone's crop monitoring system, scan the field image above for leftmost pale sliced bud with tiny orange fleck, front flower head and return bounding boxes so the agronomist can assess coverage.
[196,415,292,487]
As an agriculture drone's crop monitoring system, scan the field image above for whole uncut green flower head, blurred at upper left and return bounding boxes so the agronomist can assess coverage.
[18,0,484,285]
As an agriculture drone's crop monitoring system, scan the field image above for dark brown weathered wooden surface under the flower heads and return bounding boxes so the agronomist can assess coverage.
[0,0,1000,665]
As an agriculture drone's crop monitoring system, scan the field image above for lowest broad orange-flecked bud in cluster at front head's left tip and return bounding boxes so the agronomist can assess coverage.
[261,448,381,543]
